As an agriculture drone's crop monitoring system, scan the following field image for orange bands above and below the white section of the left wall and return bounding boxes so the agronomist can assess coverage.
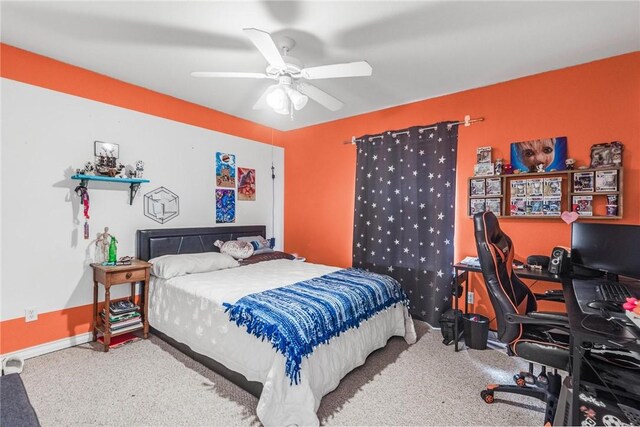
[0,43,280,354]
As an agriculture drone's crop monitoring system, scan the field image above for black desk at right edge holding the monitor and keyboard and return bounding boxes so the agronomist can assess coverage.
[562,277,640,425]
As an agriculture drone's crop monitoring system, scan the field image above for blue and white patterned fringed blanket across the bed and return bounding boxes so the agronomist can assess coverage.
[224,268,408,384]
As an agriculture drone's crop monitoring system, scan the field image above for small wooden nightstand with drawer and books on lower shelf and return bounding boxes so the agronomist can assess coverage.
[91,260,151,351]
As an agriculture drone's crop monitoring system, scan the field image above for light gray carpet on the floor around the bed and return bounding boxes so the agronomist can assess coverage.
[22,322,544,426]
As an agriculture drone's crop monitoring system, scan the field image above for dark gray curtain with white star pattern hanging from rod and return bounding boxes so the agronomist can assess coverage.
[353,122,458,326]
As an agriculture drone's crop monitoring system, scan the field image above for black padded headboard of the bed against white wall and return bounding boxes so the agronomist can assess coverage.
[136,225,266,261]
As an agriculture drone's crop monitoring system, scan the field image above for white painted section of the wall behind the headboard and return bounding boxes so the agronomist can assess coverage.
[0,79,284,320]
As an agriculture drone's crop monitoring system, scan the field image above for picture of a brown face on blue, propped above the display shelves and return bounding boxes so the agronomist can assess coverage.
[511,136,567,172]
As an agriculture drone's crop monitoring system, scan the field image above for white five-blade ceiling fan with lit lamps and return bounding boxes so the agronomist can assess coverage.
[191,28,373,114]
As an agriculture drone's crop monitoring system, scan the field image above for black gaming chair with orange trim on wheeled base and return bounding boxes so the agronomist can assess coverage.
[473,212,569,424]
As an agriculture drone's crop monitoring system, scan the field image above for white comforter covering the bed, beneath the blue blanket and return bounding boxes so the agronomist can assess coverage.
[149,260,416,426]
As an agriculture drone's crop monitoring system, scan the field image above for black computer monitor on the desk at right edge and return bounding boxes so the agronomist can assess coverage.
[571,222,640,279]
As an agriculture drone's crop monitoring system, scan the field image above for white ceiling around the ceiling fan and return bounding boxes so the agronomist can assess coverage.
[0,1,640,130]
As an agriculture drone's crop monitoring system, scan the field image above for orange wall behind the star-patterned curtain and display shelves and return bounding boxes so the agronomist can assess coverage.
[283,52,640,318]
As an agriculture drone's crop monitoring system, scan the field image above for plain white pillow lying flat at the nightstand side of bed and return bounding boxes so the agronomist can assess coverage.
[149,252,240,279]
